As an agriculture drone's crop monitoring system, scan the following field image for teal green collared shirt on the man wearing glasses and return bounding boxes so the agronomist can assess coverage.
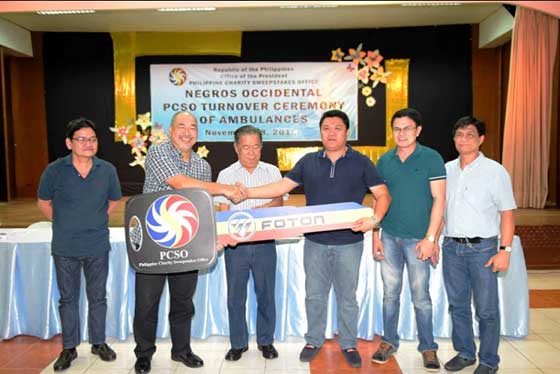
[377,143,445,239]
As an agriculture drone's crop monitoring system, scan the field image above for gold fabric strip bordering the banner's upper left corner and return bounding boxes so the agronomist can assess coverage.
[111,31,241,133]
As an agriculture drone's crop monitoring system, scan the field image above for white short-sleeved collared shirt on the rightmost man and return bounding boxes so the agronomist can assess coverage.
[443,152,517,238]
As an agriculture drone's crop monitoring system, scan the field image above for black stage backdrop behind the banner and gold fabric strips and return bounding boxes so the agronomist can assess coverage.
[44,25,472,194]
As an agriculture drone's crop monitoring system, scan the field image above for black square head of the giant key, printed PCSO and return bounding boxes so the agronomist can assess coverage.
[125,189,217,274]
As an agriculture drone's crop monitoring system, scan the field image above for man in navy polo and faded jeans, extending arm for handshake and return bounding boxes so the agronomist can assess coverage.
[247,110,391,367]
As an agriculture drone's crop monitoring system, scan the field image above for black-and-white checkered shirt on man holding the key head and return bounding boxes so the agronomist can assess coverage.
[143,140,212,193]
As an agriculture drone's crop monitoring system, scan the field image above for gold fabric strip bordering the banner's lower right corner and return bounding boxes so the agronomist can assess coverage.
[276,59,410,171]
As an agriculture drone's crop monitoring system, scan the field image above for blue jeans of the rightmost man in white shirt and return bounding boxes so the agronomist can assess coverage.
[443,237,500,368]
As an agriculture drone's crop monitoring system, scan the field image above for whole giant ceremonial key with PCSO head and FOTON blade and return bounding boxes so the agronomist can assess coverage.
[125,188,373,274]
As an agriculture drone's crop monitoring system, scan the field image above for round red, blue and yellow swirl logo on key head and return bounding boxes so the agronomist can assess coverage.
[146,195,199,249]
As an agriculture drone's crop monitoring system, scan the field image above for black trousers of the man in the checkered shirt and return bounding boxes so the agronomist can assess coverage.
[134,271,198,358]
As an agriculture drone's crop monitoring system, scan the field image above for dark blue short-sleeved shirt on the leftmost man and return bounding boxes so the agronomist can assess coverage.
[37,154,122,257]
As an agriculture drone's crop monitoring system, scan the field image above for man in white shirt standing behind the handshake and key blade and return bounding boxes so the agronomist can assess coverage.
[215,125,282,361]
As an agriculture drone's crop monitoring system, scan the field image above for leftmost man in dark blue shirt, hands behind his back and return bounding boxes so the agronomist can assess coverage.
[38,118,121,371]
